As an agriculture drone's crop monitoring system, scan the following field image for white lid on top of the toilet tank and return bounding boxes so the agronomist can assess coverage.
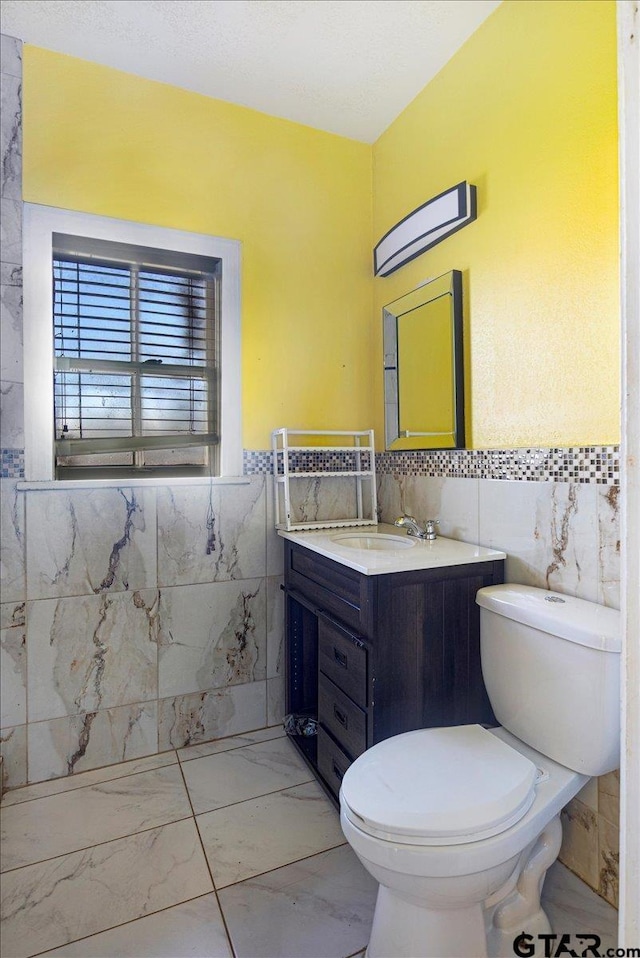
[476,584,622,652]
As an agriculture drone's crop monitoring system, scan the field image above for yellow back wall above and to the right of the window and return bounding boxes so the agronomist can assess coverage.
[23,46,373,449]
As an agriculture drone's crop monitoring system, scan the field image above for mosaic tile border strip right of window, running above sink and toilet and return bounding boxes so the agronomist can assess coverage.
[244,446,620,485]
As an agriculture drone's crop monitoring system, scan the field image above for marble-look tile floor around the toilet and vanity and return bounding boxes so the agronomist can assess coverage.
[2,728,616,958]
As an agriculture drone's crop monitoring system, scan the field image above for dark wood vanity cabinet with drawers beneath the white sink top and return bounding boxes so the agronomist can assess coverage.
[284,540,504,797]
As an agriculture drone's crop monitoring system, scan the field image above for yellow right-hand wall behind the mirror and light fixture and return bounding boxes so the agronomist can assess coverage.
[373,0,620,447]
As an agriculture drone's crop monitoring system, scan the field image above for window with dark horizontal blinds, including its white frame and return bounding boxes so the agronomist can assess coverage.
[25,204,242,479]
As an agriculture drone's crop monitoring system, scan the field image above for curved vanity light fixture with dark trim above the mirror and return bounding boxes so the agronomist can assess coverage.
[373,180,478,276]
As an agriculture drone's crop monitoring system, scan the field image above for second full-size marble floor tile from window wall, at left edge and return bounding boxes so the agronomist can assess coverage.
[2,816,213,958]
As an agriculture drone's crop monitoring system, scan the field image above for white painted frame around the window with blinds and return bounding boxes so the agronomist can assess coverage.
[23,203,242,485]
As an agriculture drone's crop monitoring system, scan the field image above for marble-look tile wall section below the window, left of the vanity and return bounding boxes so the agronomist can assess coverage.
[1,475,284,787]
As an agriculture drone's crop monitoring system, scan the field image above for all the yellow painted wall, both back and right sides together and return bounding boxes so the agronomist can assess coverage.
[24,0,619,448]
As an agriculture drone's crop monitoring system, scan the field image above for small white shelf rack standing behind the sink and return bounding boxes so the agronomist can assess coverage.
[272,427,378,532]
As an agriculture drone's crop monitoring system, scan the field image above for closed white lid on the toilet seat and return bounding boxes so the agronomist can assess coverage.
[340,725,537,845]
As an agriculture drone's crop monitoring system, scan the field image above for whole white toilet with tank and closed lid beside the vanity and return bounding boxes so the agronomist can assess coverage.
[340,585,621,958]
